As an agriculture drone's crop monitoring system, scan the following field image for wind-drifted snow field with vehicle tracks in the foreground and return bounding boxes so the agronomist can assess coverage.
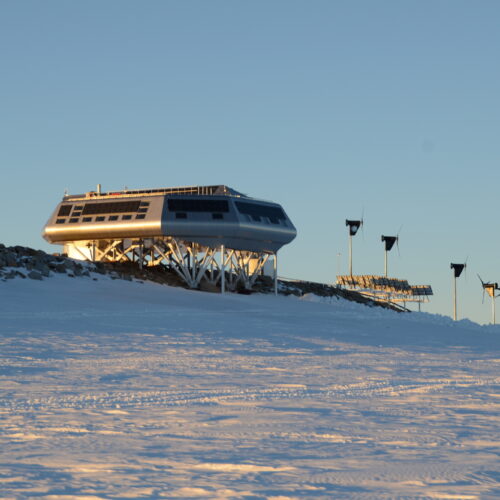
[0,276,500,500]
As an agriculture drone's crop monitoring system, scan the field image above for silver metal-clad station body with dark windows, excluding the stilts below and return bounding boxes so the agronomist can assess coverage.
[43,186,297,253]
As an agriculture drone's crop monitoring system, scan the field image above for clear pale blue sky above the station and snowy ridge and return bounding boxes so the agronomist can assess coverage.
[0,0,500,322]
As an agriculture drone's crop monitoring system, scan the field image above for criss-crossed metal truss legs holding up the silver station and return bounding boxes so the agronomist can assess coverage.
[64,237,277,292]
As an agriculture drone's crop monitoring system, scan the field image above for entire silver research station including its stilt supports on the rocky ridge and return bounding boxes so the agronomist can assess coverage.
[43,185,297,291]
